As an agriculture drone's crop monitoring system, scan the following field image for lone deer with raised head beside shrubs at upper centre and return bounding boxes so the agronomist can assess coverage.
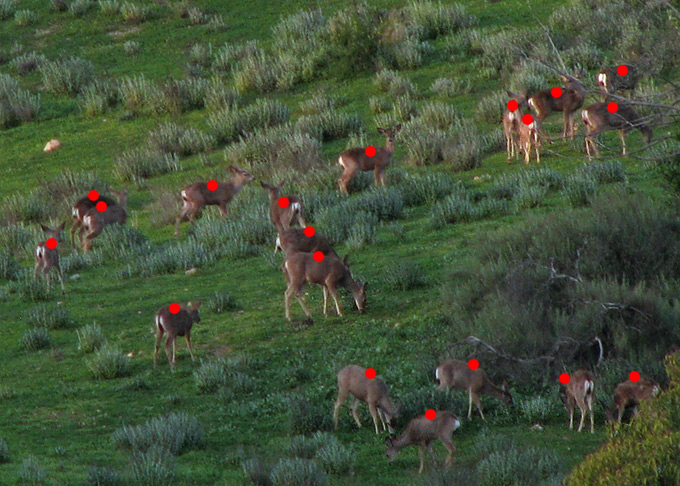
[338,124,401,194]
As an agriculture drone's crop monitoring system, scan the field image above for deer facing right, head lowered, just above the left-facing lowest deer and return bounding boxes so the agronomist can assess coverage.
[435,359,513,420]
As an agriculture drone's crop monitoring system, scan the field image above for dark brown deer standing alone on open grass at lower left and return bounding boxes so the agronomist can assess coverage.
[153,302,201,368]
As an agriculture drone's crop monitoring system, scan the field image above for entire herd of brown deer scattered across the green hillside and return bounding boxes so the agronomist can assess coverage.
[27,63,660,472]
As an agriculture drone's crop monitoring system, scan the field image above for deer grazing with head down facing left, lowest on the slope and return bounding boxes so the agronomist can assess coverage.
[385,410,460,474]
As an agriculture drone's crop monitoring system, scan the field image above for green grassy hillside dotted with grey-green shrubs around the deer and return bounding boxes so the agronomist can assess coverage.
[0,0,680,485]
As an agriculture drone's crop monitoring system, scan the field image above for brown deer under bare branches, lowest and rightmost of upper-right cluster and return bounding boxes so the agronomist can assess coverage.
[581,102,652,160]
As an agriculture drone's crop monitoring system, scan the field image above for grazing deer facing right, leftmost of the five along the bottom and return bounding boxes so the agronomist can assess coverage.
[333,365,398,434]
